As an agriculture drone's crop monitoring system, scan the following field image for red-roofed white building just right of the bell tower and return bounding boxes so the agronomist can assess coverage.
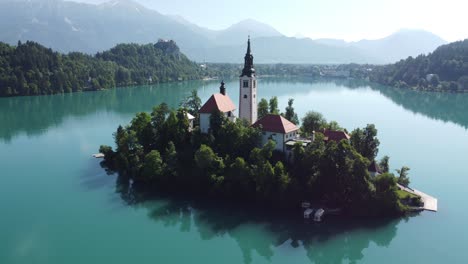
[252,114,299,152]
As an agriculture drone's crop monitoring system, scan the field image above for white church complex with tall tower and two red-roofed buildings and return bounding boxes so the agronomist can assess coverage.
[199,38,299,152]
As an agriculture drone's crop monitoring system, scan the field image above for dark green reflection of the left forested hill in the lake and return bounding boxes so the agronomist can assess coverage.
[0,81,204,141]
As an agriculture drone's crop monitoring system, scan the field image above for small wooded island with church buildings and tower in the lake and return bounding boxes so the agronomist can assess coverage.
[99,40,432,217]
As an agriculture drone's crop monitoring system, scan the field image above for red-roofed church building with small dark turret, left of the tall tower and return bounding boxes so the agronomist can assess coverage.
[198,82,236,133]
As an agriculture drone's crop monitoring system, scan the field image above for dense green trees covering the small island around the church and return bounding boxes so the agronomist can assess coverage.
[99,92,409,216]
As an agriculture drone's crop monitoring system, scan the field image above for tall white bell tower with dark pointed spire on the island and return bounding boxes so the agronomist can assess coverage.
[239,36,257,124]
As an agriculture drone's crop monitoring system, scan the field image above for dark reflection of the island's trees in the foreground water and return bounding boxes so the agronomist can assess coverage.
[117,177,399,263]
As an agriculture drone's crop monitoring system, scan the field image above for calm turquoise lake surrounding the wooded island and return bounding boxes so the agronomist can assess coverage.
[0,78,468,264]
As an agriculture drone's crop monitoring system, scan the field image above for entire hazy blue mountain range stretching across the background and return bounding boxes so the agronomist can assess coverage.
[0,0,446,63]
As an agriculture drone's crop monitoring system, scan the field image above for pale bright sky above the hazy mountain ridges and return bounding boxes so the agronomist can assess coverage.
[74,0,468,41]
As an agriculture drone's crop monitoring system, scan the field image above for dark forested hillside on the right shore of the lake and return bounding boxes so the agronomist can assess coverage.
[364,40,468,92]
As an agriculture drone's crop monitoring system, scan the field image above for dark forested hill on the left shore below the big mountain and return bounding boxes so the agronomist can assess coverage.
[0,41,203,96]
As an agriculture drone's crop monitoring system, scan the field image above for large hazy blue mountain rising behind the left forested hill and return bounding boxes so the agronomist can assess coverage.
[0,0,209,53]
